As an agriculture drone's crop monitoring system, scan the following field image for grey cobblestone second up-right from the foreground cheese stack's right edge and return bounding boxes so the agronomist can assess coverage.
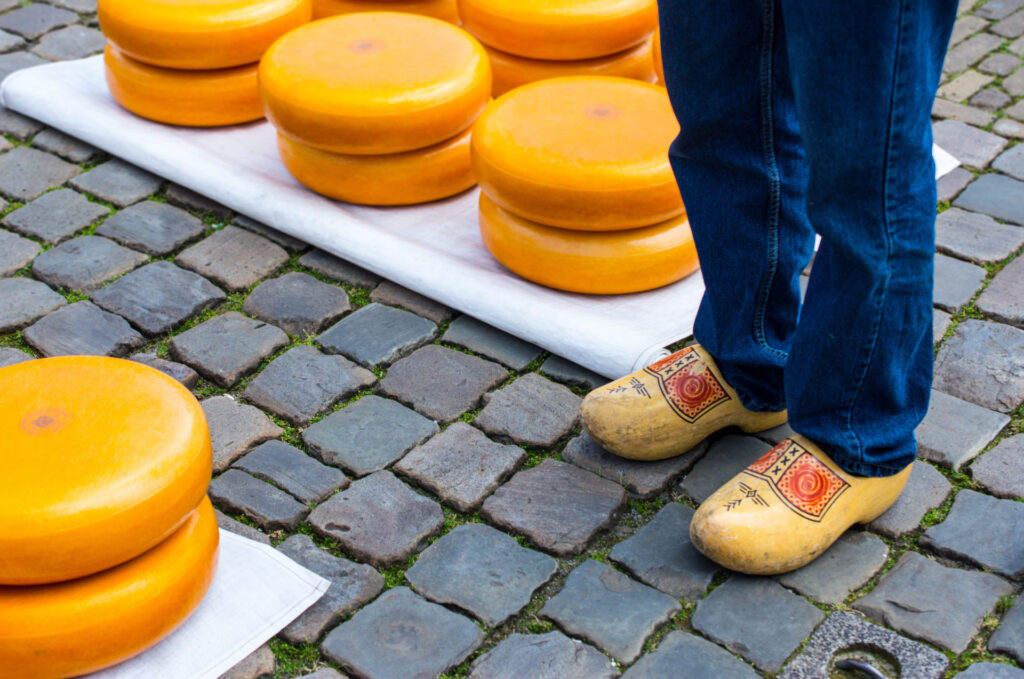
[243,345,377,426]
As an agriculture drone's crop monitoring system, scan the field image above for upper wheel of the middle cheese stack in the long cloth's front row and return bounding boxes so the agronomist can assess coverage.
[259,12,490,155]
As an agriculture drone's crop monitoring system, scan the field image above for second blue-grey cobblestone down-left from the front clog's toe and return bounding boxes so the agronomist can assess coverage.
[541,559,682,663]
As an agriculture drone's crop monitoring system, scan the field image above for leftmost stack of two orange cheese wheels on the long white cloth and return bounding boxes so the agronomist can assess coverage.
[97,0,312,127]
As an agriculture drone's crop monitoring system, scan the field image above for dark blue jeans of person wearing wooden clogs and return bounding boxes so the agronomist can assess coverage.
[659,0,956,476]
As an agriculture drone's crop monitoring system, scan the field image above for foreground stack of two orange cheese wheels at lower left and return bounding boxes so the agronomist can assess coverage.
[0,356,218,679]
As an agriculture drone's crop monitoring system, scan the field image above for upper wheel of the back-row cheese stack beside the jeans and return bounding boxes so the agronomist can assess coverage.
[459,0,657,59]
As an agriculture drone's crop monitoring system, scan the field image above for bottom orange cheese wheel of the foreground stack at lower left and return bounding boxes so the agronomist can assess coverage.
[0,499,220,679]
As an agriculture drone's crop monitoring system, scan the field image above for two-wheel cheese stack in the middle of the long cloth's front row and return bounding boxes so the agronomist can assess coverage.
[259,12,490,205]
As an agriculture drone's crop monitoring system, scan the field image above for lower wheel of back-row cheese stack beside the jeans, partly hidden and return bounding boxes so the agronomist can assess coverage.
[483,40,657,96]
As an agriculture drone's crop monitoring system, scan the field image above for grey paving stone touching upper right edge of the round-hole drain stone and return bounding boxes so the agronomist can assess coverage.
[853,552,1013,653]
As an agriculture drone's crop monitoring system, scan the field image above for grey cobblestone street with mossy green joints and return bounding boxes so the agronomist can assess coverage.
[0,0,1024,679]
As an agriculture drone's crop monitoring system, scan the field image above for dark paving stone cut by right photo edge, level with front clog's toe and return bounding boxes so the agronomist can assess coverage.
[921,489,1024,579]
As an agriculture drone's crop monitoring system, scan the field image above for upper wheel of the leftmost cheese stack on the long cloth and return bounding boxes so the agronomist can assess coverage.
[97,0,312,70]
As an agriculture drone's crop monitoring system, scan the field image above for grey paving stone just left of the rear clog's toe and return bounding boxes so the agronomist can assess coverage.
[473,373,583,448]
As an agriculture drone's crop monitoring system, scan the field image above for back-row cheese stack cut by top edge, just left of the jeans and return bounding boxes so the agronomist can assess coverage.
[459,0,657,96]
